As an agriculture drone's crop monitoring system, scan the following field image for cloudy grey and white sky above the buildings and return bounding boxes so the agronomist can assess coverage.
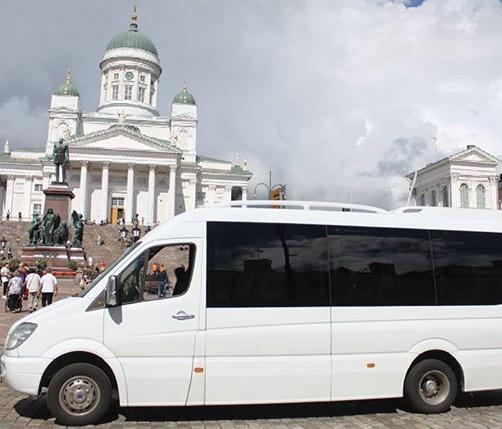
[0,0,502,208]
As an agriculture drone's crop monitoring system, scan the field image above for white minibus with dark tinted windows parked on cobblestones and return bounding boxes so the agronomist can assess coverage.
[1,201,502,425]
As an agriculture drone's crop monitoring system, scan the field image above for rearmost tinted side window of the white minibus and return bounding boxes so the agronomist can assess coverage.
[431,231,502,305]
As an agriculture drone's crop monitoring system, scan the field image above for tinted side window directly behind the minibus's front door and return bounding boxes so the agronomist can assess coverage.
[207,222,329,307]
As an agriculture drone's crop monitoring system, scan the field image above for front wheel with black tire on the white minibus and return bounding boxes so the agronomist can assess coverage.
[47,363,112,426]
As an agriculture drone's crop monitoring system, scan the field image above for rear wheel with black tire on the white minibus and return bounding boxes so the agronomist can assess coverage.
[404,359,458,414]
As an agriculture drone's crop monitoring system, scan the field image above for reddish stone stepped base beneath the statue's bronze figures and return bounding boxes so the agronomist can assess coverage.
[21,246,87,274]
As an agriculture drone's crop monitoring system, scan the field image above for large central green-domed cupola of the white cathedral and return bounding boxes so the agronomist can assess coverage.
[98,7,162,117]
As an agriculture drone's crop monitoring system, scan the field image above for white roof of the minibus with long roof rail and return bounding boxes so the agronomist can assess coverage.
[148,200,502,238]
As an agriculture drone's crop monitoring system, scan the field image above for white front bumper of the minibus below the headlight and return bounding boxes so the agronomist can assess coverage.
[0,355,51,396]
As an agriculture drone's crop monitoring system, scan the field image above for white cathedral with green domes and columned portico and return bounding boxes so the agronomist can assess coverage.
[0,10,252,225]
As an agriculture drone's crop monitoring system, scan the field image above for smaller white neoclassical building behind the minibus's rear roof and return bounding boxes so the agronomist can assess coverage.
[406,145,500,210]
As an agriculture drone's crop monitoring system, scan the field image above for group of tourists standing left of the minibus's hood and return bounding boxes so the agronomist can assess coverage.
[0,263,58,313]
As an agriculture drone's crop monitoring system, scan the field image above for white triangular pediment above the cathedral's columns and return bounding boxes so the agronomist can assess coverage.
[68,125,180,154]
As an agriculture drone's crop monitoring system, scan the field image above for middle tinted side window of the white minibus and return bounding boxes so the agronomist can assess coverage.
[328,226,436,306]
